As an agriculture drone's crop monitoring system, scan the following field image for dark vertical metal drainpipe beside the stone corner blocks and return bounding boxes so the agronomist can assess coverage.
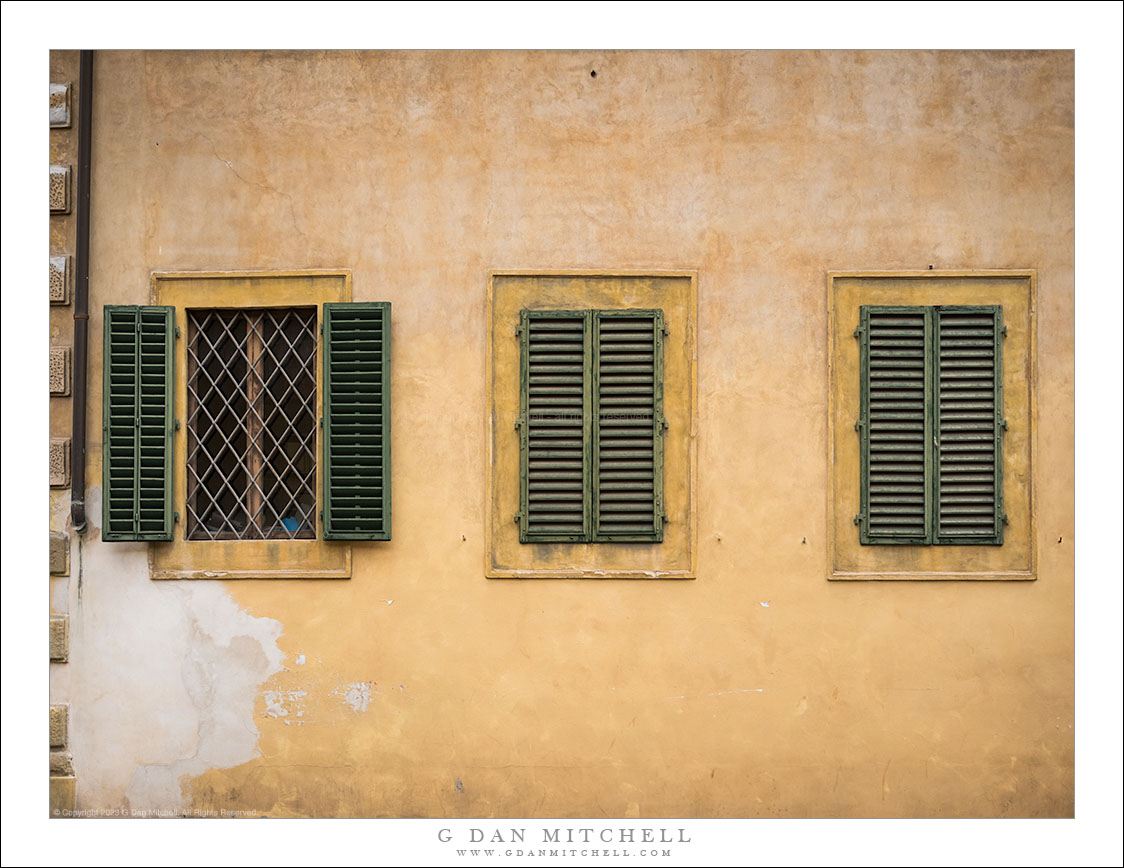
[71,51,93,533]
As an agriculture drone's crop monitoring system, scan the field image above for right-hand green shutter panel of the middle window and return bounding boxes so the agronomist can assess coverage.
[591,310,663,542]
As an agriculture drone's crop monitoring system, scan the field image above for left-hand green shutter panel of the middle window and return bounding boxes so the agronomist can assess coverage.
[519,310,590,542]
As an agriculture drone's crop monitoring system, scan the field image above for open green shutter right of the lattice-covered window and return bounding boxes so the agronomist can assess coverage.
[320,301,390,540]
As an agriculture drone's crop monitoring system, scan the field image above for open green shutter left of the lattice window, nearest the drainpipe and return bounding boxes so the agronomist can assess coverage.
[101,305,174,542]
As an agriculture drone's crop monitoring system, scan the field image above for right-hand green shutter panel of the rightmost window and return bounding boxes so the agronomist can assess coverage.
[933,306,1003,545]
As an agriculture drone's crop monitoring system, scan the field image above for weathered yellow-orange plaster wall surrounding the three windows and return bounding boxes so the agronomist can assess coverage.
[69,52,1073,816]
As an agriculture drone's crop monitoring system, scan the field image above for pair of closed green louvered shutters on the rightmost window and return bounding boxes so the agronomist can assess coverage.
[855,306,1004,545]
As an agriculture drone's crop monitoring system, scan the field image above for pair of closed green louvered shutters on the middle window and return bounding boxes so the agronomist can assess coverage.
[518,309,665,543]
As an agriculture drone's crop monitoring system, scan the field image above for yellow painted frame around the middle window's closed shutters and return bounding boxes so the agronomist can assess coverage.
[484,269,698,579]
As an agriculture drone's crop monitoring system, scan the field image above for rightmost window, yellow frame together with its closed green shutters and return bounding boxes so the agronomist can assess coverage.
[826,269,1037,581]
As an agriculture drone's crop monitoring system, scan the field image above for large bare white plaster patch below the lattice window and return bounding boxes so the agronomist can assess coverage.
[67,486,284,813]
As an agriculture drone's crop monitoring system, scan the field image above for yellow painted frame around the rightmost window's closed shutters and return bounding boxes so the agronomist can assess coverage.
[827,269,1037,581]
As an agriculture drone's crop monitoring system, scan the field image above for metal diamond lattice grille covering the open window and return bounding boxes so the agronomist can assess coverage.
[187,308,316,540]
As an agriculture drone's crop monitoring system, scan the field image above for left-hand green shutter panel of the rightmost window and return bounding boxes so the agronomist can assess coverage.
[858,306,932,545]
